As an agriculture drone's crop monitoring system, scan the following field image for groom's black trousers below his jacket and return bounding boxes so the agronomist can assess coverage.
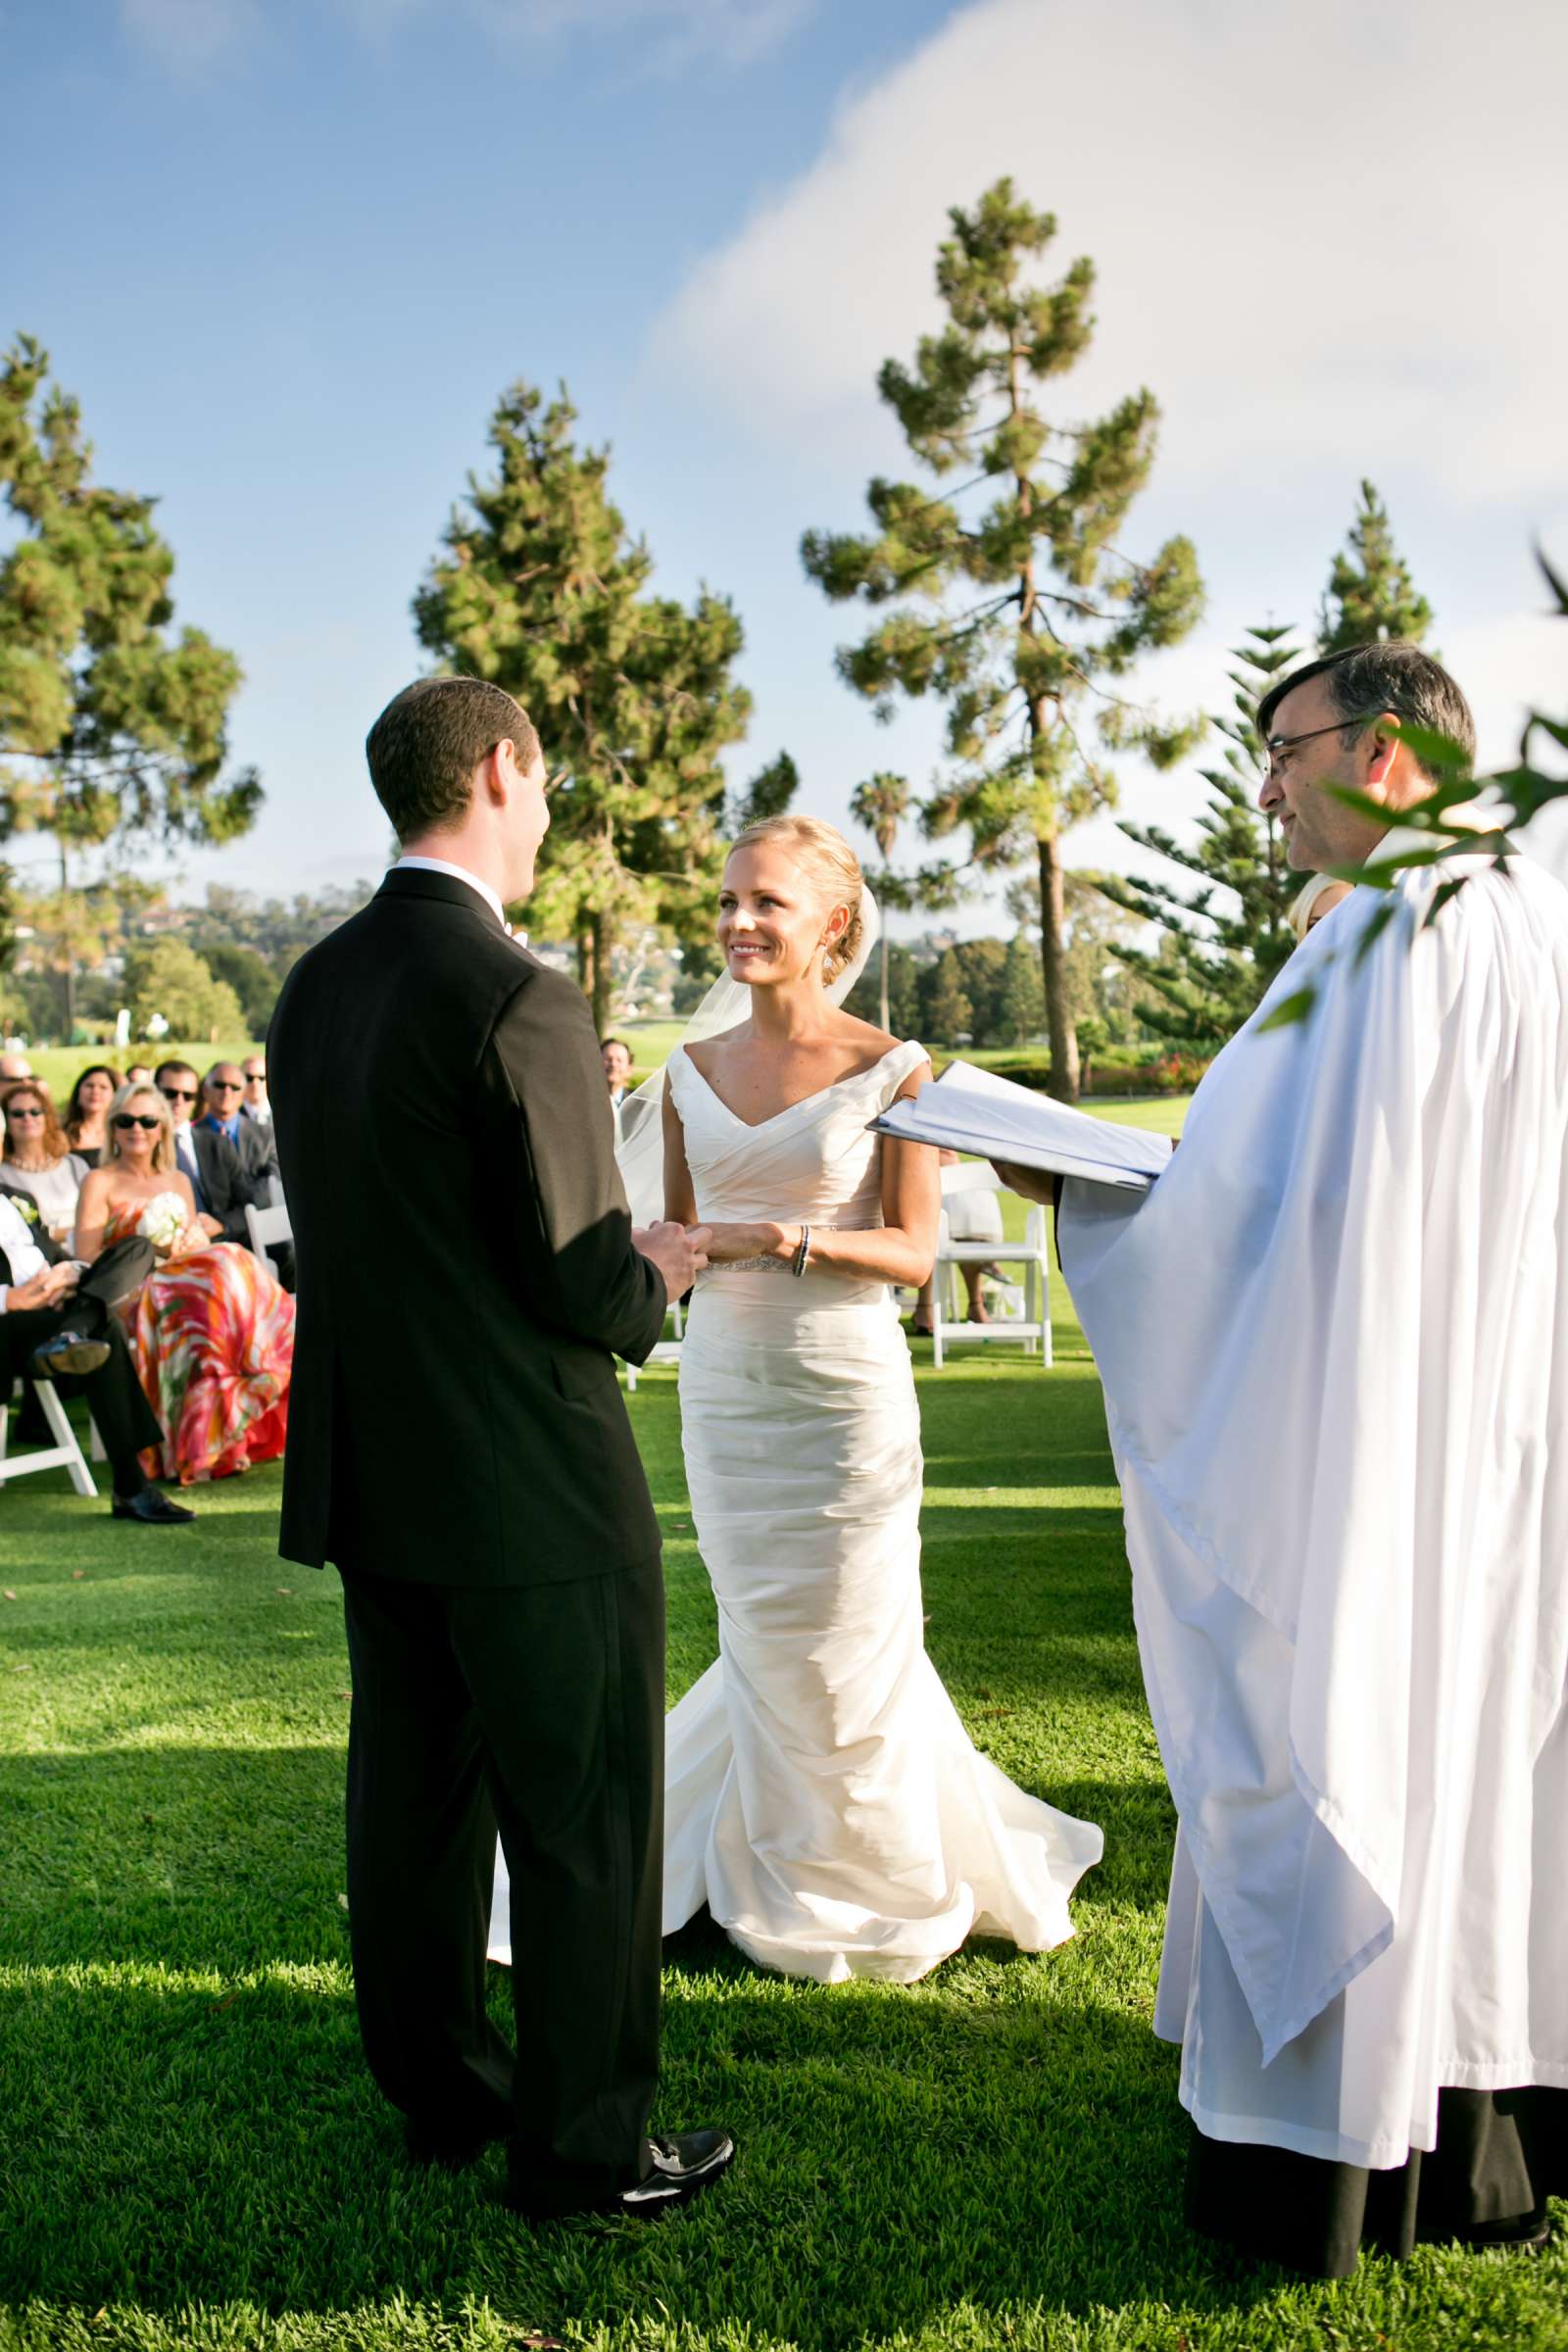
[343,1559,665,2211]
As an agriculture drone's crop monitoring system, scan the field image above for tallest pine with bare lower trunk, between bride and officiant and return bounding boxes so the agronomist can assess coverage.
[802,178,1203,1101]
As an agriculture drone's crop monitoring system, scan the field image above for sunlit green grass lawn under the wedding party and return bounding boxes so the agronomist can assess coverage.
[0,1242,1568,2352]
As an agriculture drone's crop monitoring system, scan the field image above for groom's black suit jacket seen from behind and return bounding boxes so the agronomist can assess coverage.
[268,870,665,1586]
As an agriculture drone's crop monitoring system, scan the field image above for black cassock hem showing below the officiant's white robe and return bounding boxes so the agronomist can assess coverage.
[1187,2088,1568,2279]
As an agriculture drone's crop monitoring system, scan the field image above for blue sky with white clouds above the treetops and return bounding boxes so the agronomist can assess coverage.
[0,0,1568,927]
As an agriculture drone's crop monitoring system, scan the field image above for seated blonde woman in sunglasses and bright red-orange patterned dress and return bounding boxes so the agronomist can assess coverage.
[75,1087,294,1487]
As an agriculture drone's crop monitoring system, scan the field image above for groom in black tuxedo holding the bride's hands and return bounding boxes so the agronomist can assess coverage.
[268,677,733,2216]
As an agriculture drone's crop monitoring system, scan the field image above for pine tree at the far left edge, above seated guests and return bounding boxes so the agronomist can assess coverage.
[0,334,261,1035]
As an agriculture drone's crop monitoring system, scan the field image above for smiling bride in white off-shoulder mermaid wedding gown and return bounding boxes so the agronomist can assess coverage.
[491,816,1102,1983]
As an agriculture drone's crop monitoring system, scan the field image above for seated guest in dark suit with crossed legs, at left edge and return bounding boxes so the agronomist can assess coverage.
[0,1193,195,1527]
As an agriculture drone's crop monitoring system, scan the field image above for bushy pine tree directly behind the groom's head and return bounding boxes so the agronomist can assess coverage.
[414,383,761,1030]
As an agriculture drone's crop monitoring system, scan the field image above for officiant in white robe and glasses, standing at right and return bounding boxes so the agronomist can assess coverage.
[1018,645,1568,2277]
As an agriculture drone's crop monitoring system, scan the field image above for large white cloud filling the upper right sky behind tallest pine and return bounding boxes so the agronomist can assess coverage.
[644,0,1568,898]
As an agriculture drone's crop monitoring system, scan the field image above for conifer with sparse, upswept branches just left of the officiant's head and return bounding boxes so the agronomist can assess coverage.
[1096,625,1302,1054]
